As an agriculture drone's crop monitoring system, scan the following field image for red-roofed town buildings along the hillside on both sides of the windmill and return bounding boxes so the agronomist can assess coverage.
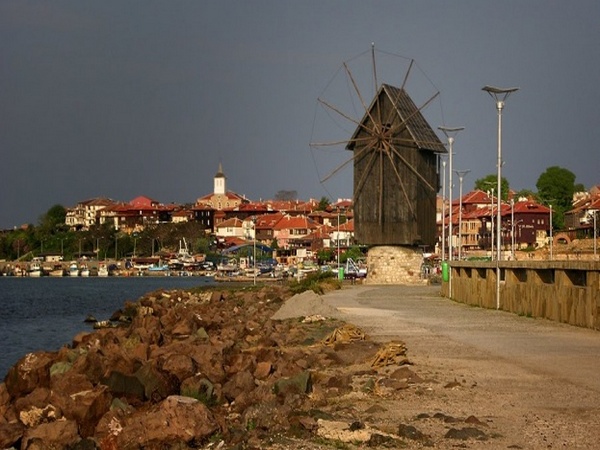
[65,164,600,257]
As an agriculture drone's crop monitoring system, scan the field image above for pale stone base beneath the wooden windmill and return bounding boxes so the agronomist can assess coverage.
[366,245,427,284]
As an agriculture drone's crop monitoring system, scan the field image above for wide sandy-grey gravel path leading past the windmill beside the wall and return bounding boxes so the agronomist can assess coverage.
[281,285,600,449]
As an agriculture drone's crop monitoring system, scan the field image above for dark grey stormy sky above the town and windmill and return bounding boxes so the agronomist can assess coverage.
[0,0,600,229]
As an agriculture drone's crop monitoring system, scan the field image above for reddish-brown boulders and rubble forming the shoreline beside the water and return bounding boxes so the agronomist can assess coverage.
[0,284,496,450]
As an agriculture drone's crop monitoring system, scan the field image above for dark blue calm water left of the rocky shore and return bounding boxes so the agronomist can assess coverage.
[0,277,216,380]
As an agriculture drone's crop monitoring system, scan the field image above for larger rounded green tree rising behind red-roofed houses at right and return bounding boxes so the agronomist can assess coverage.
[536,166,575,230]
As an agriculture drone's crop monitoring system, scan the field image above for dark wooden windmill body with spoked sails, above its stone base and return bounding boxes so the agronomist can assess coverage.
[311,46,446,246]
